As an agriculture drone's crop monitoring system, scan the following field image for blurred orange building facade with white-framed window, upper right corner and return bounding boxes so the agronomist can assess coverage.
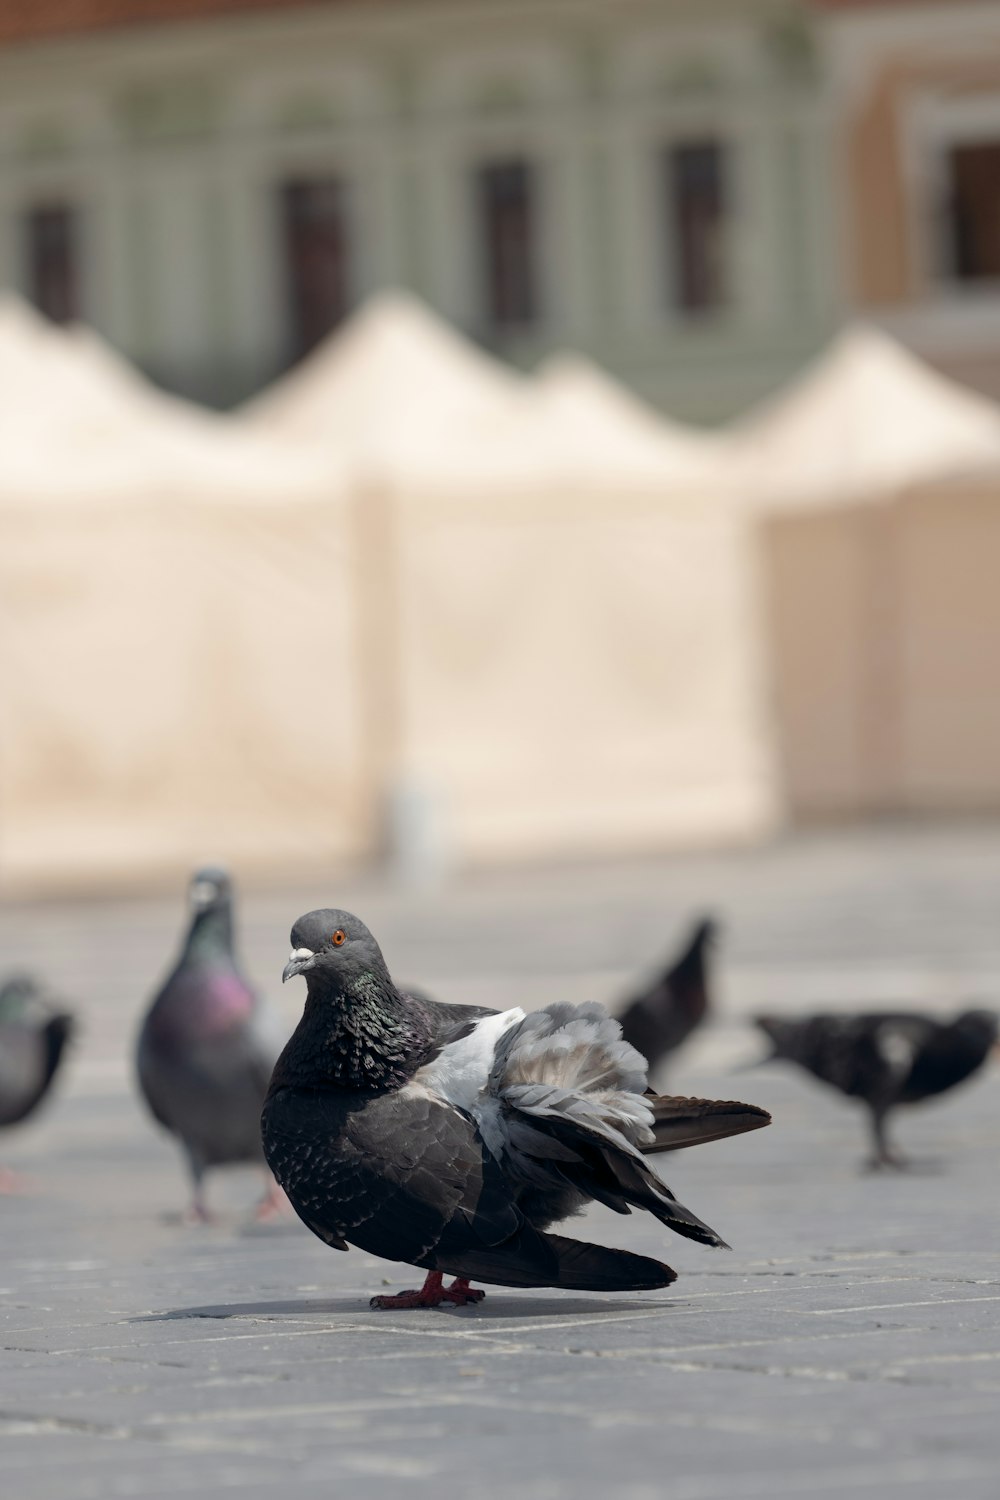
[825,0,1000,398]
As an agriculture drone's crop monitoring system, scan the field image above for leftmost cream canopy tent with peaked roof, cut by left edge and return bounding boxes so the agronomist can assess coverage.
[0,302,359,888]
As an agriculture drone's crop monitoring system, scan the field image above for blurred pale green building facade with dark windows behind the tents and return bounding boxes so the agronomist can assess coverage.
[0,0,843,420]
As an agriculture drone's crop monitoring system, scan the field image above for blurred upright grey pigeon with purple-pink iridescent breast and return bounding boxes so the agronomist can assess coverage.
[136,869,283,1221]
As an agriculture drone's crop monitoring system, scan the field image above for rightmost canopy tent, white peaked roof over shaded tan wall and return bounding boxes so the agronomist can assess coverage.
[746,329,1000,818]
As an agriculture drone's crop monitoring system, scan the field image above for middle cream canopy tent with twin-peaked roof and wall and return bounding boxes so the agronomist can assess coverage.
[244,294,774,861]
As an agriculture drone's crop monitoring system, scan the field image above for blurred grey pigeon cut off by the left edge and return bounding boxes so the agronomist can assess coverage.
[0,975,73,1190]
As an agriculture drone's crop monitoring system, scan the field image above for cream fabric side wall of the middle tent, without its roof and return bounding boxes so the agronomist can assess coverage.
[386,489,774,860]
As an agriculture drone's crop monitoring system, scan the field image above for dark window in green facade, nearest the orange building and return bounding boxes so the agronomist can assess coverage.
[664,141,729,314]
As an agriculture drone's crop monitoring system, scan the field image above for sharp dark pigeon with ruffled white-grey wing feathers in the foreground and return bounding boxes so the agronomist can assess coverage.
[261,909,769,1308]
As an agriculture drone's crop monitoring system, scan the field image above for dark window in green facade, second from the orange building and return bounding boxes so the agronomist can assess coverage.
[475,161,538,332]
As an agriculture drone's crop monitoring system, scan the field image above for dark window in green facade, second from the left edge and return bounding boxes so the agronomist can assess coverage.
[282,177,349,359]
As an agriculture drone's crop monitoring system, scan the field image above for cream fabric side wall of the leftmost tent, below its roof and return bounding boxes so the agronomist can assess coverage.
[0,497,373,890]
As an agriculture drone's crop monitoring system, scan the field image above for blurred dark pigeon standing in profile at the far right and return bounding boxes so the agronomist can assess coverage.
[756,1011,997,1169]
